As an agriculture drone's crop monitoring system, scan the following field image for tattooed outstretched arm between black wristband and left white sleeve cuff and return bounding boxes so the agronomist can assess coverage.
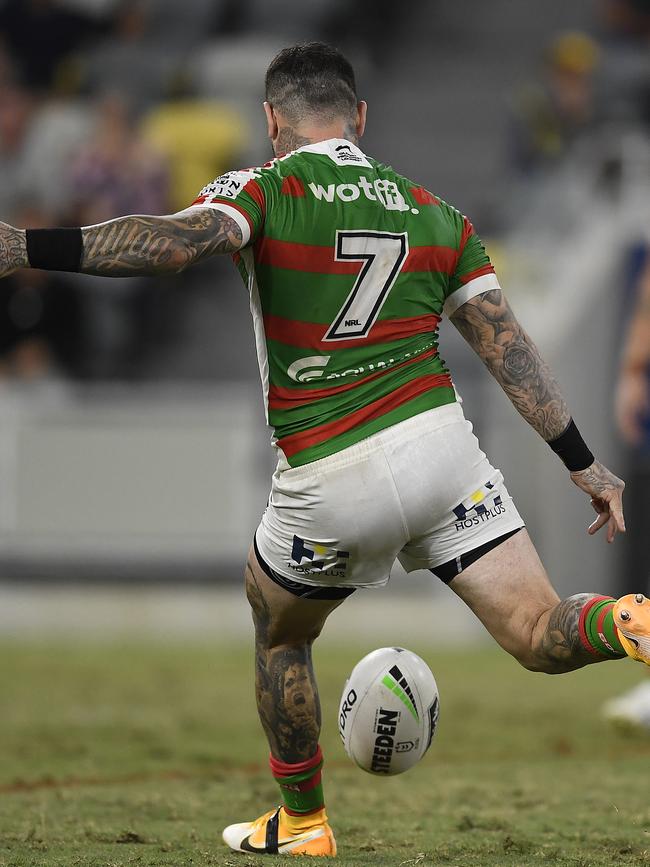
[80,208,242,277]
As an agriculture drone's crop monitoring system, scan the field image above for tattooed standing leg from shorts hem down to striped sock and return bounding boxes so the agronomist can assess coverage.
[246,552,342,763]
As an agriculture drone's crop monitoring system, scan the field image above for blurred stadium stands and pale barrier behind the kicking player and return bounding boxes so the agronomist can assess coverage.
[0,0,650,643]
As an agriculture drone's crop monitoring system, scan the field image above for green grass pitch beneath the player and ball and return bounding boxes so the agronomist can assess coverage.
[0,637,650,867]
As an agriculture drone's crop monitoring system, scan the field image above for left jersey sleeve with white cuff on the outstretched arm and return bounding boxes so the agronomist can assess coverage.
[191,169,267,247]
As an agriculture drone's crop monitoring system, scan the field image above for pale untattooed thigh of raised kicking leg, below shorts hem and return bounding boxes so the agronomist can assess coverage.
[449,529,559,665]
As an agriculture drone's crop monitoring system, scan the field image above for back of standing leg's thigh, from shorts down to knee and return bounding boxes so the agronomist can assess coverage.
[246,548,344,647]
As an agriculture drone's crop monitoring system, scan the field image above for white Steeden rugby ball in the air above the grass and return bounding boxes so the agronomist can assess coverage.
[339,647,440,775]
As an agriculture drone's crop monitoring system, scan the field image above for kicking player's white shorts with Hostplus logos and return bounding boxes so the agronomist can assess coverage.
[255,403,523,588]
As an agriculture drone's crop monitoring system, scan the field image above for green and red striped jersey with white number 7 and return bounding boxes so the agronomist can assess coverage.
[194,139,498,466]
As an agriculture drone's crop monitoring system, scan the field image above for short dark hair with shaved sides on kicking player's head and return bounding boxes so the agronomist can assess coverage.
[265,42,357,123]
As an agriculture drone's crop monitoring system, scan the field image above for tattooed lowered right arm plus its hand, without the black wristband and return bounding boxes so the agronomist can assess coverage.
[451,289,625,542]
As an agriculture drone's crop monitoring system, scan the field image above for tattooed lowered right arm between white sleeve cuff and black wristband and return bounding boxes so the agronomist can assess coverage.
[451,289,571,441]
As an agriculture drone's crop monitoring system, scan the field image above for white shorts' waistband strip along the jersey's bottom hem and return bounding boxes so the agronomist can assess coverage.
[276,403,465,479]
